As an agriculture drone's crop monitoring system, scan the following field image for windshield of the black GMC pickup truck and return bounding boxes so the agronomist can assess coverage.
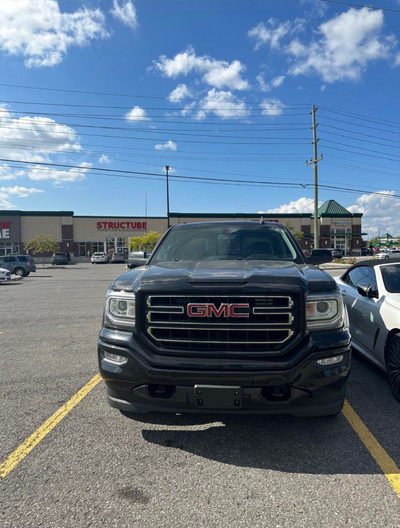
[151,224,303,264]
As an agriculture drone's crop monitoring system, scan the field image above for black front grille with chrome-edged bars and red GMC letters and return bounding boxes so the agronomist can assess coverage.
[143,295,299,353]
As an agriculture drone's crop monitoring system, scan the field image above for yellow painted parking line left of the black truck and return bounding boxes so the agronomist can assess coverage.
[0,374,101,481]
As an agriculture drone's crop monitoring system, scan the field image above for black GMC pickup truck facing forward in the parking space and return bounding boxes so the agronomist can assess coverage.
[98,221,350,416]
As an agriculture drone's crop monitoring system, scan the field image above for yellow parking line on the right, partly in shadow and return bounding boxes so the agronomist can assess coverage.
[343,400,400,497]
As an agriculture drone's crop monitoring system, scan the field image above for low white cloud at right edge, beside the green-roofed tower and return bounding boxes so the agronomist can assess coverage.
[346,190,400,239]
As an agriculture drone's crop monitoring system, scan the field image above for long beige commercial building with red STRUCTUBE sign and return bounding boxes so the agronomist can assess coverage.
[0,200,366,259]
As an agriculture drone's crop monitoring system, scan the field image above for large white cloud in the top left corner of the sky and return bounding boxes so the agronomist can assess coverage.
[0,0,108,67]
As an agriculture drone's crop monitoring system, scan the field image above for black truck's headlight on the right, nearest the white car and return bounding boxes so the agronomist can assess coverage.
[306,292,348,330]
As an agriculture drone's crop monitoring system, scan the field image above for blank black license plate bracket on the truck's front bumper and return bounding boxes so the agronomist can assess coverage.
[194,385,242,410]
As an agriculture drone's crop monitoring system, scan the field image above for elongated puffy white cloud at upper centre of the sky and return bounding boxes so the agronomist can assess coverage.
[154,46,249,90]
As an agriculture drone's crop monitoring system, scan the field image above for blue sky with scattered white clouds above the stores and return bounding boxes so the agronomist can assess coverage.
[0,0,400,236]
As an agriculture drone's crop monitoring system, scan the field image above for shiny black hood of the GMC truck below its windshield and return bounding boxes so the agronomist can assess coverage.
[112,260,337,292]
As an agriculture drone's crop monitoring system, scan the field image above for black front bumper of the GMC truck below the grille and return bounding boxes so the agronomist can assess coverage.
[98,328,351,416]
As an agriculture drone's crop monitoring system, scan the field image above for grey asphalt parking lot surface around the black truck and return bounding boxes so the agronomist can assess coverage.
[0,263,400,528]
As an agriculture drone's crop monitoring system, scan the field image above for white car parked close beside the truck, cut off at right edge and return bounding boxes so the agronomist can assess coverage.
[336,259,400,401]
